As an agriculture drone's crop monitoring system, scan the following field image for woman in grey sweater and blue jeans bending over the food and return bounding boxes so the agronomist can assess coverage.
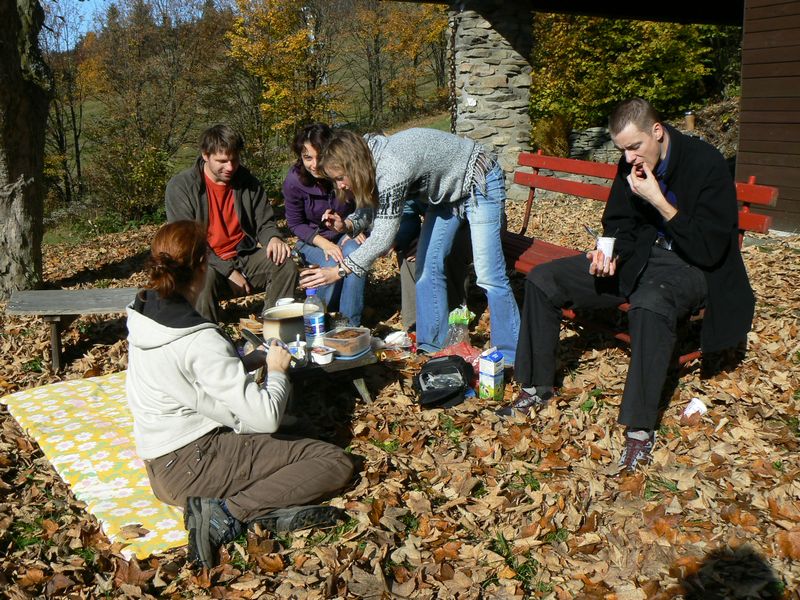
[300,128,519,366]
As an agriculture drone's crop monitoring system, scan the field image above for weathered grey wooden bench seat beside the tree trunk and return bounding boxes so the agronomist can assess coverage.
[6,288,138,316]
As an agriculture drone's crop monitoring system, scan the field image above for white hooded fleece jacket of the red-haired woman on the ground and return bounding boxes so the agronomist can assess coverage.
[126,292,289,459]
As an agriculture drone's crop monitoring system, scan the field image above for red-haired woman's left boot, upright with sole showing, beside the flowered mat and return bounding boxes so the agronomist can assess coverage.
[183,496,244,569]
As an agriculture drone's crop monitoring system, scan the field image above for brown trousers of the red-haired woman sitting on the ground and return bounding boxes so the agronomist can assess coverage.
[145,428,353,523]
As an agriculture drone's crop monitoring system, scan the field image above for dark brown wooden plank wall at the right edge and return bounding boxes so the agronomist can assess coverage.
[736,0,800,231]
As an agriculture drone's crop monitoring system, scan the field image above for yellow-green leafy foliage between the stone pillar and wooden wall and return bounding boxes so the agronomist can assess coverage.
[531,13,736,127]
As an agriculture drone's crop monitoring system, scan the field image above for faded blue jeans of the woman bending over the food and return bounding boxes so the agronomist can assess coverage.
[417,166,519,366]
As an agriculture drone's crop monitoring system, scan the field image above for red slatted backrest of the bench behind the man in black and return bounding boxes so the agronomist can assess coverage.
[514,150,778,235]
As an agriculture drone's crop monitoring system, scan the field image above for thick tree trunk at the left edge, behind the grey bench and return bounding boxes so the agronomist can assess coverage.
[0,0,50,298]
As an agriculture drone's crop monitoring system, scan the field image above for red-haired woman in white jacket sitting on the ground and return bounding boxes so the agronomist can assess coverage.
[127,221,353,567]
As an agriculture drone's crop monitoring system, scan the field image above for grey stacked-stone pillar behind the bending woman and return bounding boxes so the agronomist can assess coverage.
[450,1,532,200]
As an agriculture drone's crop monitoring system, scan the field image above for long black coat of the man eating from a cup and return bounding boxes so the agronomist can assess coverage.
[603,126,755,352]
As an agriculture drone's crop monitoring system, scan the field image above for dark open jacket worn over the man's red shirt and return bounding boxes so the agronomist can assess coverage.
[166,157,283,277]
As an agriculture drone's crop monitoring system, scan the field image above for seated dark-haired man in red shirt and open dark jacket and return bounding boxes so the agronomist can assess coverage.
[166,125,297,322]
